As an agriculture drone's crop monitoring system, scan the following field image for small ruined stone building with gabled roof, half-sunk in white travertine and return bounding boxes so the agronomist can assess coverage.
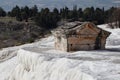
[52,22,110,52]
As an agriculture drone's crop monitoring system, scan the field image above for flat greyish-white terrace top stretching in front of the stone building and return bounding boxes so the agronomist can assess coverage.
[21,47,120,62]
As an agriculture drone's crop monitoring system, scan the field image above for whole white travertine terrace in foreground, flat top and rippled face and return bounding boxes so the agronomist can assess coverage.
[10,47,120,80]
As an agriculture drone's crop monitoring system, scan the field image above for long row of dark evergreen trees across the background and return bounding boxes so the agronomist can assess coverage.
[0,5,120,29]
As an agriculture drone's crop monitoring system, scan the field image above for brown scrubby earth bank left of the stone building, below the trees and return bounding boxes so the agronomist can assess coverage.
[0,21,47,48]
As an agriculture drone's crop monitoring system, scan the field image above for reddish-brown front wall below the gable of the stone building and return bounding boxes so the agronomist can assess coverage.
[68,35,96,51]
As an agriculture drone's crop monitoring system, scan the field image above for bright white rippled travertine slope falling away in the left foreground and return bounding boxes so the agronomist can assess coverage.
[9,50,95,80]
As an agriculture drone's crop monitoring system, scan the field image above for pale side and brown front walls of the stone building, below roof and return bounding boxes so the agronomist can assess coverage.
[55,30,107,51]
